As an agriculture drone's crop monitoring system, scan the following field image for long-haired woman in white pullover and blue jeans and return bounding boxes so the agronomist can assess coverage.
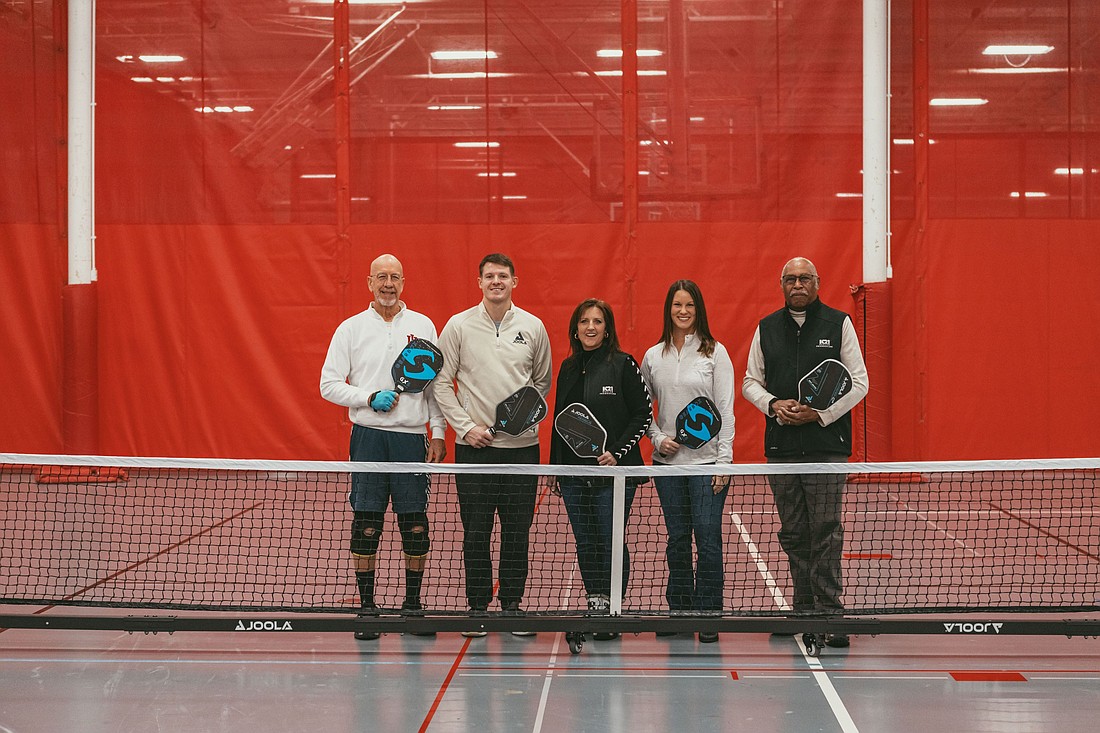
[641,280,736,642]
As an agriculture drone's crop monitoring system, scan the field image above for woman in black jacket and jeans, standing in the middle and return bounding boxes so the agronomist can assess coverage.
[550,298,652,638]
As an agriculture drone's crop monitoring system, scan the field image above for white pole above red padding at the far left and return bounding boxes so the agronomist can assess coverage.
[67,0,96,285]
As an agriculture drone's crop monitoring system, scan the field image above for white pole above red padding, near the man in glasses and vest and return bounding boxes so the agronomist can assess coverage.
[864,0,890,283]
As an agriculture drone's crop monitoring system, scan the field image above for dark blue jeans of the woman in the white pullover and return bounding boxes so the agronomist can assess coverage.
[653,475,729,611]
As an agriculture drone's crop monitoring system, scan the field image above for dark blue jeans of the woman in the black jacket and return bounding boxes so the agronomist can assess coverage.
[560,475,638,598]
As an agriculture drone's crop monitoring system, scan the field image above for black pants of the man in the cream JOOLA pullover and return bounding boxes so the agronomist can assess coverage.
[454,445,539,610]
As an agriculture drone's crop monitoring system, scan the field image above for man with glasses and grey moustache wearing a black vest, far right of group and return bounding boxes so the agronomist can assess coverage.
[741,258,868,646]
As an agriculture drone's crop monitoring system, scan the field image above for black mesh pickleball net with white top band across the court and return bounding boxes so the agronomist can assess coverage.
[0,455,1100,617]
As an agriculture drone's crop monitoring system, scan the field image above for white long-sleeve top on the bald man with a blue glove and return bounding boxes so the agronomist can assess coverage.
[321,303,447,439]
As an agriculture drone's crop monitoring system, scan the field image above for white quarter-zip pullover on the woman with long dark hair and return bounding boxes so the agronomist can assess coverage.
[641,333,737,466]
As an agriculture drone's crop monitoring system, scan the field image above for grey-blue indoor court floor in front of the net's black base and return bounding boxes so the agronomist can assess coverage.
[0,606,1100,733]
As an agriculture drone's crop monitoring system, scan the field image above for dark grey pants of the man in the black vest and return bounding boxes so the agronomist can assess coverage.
[768,456,848,613]
